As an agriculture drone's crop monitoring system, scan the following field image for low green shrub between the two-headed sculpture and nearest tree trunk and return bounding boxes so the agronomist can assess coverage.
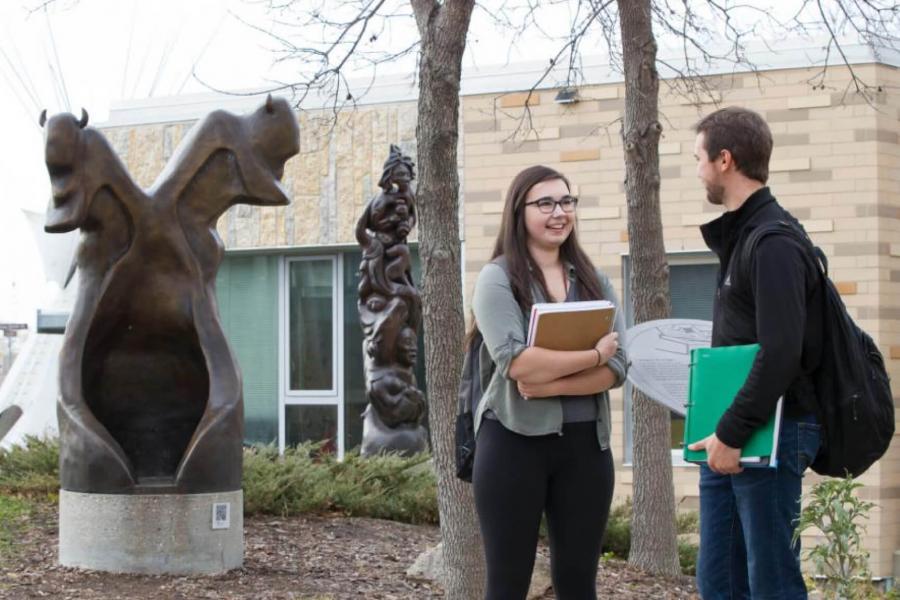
[243,443,438,523]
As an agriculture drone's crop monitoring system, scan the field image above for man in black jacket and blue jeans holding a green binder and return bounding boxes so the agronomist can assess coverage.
[691,107,823,600]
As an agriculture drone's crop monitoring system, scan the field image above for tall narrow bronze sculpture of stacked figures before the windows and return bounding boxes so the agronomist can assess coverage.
[356,145,428,456]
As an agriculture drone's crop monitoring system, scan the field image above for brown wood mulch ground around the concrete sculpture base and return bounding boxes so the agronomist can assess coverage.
[0,507,698,600]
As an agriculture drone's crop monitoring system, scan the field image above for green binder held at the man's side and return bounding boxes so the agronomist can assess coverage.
[684,344,782,467]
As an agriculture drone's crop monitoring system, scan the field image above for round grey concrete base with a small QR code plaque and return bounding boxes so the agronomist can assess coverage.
[59,490,244,575]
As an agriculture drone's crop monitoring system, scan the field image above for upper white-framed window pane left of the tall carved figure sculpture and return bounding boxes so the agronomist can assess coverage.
[288,258,335,391]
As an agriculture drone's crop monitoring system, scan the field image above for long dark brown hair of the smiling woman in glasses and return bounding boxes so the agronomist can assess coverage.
[466,165,603,348]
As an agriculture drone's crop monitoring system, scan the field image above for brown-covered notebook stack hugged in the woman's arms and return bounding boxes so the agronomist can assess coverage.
[528,300,616,350]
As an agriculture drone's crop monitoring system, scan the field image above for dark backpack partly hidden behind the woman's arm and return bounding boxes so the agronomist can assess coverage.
[456,331,493,482]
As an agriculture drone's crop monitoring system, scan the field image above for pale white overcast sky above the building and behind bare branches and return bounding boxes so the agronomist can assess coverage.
[0,0,852,323]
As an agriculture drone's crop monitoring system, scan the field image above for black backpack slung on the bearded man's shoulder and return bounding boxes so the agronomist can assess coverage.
[741,221,894,477]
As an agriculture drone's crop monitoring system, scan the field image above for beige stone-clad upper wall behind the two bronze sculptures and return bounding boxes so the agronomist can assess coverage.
[103,102,416,249]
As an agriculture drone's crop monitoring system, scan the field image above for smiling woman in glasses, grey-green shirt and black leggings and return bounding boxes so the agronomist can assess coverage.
[472,166,626,600]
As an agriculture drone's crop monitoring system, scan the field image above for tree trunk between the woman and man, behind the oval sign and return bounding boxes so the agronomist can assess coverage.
[618,0,679,574]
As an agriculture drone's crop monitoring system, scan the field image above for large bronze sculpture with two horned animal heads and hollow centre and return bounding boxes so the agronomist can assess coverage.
[41,96,299,494]
